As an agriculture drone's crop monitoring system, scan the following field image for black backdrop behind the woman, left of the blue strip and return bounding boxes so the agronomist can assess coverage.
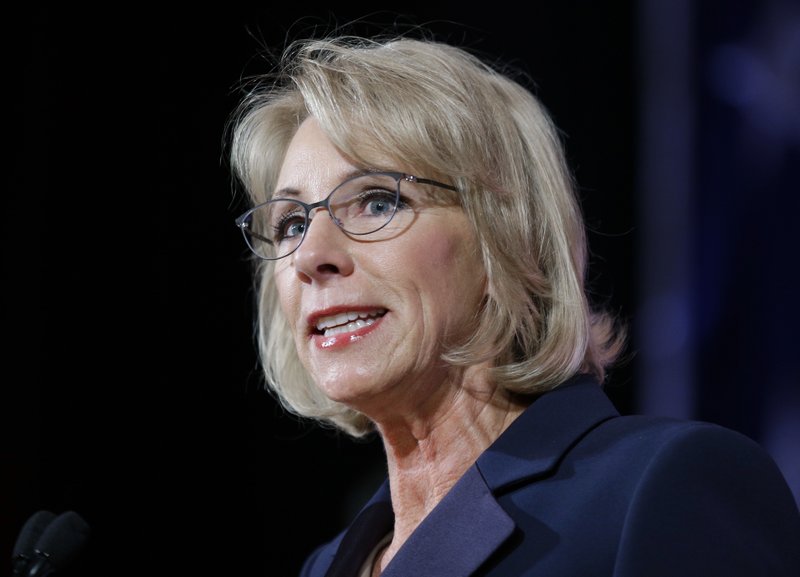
[0,0,796,576]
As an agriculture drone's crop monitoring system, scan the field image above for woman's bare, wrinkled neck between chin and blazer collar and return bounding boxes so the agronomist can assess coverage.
[368,366,525,570]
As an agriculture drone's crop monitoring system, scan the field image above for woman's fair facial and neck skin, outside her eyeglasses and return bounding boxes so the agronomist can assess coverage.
[275,119,523,572]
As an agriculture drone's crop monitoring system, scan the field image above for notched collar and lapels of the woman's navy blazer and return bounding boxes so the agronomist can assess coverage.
[325,376,619,577]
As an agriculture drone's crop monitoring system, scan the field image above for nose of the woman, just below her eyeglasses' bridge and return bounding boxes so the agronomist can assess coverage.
[288,207,353,284]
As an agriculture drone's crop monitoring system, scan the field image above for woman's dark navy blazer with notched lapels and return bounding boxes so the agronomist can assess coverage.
[301,377,800,577]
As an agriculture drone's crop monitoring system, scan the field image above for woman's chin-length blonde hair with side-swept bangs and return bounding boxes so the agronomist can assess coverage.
[225,36,624,436]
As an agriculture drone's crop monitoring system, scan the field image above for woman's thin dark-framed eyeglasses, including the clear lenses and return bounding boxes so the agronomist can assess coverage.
[236,172,457,260]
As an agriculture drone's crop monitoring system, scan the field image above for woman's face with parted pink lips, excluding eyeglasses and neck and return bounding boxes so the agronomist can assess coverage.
[274,118,485,417]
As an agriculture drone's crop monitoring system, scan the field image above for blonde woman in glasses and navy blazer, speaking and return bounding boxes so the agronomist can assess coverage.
[231,38,800,577]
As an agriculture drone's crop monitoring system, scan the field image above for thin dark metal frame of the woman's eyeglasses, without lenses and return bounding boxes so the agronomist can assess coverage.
[234,171,458,261]
